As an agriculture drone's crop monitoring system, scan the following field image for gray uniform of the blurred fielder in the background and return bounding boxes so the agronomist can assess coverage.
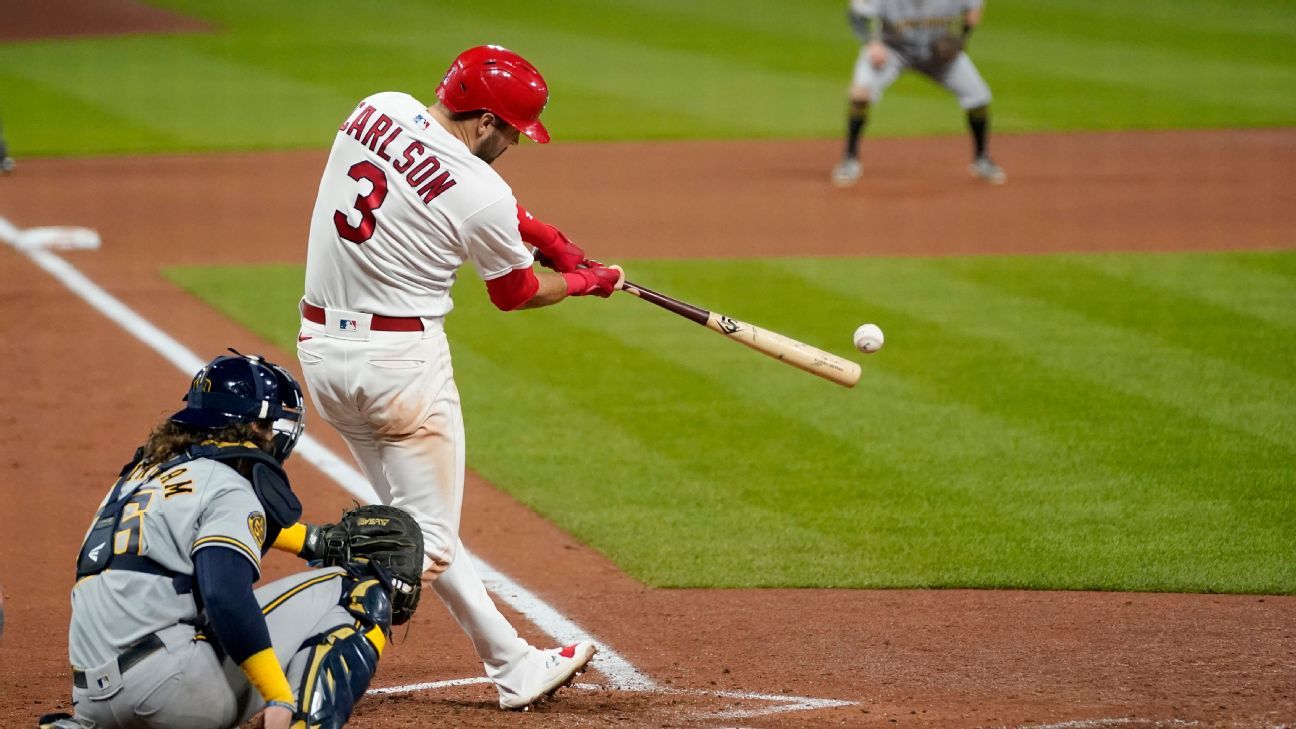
[850,0,991,109]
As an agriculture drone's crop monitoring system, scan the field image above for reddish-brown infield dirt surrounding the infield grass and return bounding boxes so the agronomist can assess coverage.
[0,130,1296,729]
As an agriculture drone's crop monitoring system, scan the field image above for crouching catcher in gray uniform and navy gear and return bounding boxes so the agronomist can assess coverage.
[40,353,422,729]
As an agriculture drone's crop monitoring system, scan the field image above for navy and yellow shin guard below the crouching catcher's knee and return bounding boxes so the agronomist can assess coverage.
[293,625,385,729]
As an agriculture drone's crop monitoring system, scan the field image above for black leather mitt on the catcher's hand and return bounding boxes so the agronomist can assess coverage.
[319,505,422,625]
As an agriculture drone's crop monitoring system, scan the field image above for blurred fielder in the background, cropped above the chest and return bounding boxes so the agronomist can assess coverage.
[832,0,1008,187]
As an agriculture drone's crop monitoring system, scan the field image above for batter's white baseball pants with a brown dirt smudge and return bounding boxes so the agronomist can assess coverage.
[297,317,538,693]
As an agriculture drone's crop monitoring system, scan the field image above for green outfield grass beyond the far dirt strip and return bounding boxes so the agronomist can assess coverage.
[0,0,1296,156]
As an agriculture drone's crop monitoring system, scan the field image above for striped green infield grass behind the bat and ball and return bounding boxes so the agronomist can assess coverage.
[168,252,1296,593]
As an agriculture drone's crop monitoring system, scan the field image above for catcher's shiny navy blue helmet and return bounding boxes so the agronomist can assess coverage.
[171,349,306,460]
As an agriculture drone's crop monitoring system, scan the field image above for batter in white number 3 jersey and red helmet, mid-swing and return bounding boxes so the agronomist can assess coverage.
[298,45,622,708]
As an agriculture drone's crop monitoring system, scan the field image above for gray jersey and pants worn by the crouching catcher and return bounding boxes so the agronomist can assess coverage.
[69,458,355,729]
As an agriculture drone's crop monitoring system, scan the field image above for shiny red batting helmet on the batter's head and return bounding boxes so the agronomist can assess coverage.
[437,45,550,144]
